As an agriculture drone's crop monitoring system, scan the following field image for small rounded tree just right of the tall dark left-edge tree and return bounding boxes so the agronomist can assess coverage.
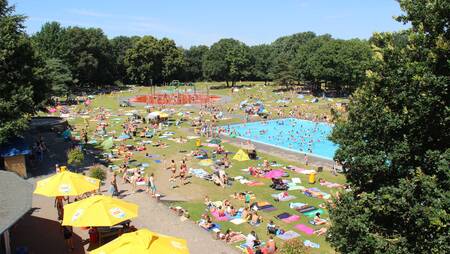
[44,58,73,96]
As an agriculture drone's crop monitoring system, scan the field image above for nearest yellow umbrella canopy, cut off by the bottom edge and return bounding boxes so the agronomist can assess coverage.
[90,229,189,254]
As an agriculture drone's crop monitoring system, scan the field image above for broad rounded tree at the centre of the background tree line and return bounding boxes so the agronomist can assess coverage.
[203,39,251,85]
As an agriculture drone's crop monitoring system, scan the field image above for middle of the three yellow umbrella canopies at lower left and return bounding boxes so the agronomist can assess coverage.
[62,195,139,227]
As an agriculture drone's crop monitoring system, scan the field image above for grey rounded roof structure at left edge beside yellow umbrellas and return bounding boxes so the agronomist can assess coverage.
[0,170,33,254]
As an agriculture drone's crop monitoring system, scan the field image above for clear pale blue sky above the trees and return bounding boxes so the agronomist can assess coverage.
[13,0,405,47]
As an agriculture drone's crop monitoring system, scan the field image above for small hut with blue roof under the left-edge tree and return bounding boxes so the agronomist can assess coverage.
[0,138,31,177]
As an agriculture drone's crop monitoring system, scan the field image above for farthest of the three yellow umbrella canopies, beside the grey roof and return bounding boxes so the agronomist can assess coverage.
[34,170,100,197]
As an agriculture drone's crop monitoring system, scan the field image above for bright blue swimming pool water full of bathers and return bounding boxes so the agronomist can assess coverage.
[223,118,338,160]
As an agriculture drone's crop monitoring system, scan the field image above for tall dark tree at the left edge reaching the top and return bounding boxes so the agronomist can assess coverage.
[0,1,49,144]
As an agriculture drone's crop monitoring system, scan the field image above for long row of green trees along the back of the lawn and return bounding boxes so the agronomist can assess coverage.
[30,22,371,93]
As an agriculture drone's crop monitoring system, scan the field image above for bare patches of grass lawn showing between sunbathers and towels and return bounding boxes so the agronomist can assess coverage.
[59,82,345,253]
